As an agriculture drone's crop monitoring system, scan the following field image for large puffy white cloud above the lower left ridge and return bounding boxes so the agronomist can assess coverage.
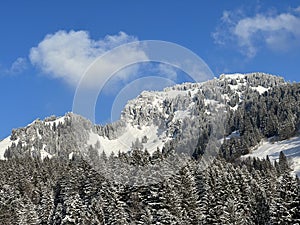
[29,30,147,87]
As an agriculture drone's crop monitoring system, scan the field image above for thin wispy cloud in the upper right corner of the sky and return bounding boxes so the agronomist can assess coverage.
[213,7,300,58]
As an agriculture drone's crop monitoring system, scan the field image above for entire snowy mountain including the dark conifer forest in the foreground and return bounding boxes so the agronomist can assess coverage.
[0,73,300,224]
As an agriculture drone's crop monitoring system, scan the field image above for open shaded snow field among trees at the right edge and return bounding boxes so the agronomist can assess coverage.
[243,137,300,176]
